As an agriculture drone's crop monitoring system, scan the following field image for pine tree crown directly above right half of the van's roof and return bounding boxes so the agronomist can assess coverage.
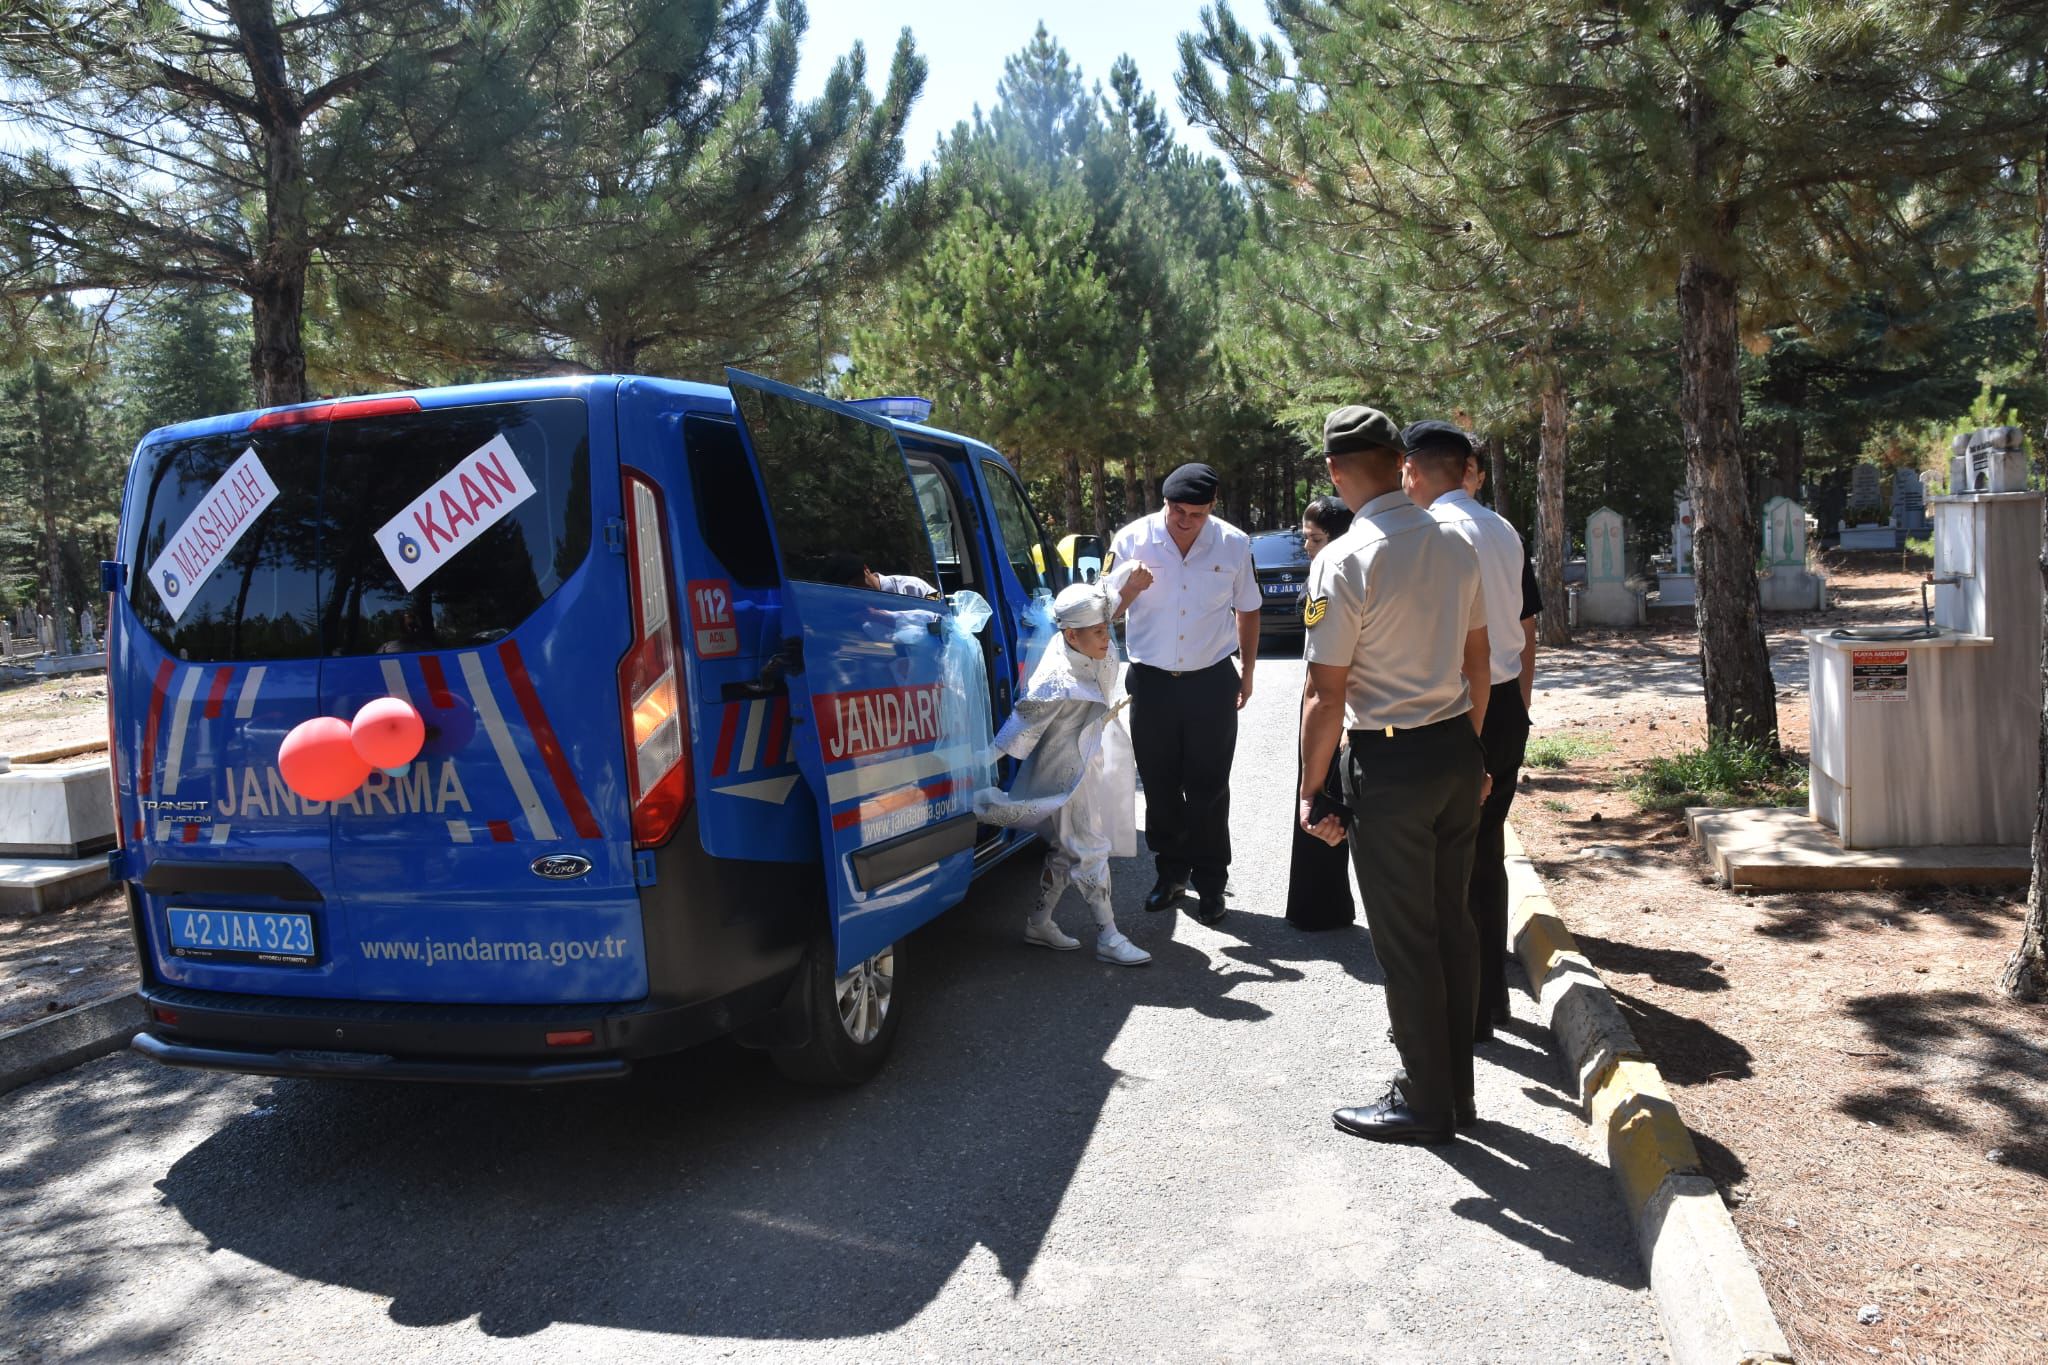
[338,0,926,381]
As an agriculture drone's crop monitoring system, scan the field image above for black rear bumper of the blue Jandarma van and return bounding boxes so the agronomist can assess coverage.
[131,974,791,1085]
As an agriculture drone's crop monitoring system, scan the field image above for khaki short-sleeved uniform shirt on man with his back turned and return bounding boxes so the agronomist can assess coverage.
[1303,491,1487,731]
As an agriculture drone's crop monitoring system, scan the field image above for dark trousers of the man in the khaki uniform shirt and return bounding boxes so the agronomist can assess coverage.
[1343,716,1485,1119]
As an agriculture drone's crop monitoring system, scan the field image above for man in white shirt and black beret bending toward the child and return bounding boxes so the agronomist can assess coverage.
[1106,465,1260,925]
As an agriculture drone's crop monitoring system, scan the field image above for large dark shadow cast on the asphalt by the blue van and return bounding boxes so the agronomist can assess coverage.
[123,855,1288,1340]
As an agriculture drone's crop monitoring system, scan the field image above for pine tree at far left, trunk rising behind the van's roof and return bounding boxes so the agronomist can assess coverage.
[0,0,516,405]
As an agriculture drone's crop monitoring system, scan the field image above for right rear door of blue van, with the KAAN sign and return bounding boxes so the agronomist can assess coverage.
[322,391,647,1003]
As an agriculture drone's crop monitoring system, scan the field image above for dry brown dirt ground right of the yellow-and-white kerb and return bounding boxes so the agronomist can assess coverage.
[1513,555,2048,1365]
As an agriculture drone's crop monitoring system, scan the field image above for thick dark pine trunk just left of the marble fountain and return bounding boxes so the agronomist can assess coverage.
[1677,250,1778,751]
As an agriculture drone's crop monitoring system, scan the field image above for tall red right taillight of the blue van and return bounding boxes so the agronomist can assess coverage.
[618,471,690,847]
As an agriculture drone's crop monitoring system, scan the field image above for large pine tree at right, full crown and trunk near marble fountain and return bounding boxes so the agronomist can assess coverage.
[1184,0,2044,745]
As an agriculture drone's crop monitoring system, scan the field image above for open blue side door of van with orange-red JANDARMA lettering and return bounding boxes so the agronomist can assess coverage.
[725,368,987,972]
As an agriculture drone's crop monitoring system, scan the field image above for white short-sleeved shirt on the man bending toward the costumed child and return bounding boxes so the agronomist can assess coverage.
[1106,510,1260,673]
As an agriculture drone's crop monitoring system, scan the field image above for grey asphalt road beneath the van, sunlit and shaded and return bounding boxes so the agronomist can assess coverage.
[0,657,1665,1361]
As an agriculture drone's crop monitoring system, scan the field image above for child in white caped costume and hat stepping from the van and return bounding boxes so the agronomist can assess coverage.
[975,583,1151,966]
